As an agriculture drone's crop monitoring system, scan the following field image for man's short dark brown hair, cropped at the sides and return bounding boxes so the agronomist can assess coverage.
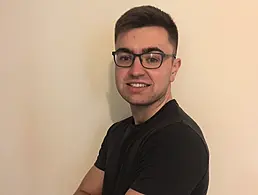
[115,5,178,50]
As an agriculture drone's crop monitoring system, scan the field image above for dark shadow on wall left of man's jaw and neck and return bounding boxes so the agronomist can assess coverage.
[106,62,131,122]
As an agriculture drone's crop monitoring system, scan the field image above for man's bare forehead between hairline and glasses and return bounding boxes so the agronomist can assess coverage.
[115,27,173,53]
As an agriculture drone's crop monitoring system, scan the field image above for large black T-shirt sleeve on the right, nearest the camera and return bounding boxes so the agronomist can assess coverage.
[131,124,209,195]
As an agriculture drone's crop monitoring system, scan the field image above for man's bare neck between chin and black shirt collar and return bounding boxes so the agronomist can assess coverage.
[131,94,172,125]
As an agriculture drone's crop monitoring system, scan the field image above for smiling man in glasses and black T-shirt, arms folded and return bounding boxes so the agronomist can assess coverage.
[75,6,209,195]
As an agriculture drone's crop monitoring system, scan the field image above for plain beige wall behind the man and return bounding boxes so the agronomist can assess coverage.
[0,0,258,195]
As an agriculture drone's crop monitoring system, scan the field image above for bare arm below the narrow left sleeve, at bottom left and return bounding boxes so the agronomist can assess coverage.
[74,166,104,195]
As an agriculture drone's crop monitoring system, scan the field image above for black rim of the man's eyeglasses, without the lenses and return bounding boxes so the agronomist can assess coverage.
[112,50,176,69]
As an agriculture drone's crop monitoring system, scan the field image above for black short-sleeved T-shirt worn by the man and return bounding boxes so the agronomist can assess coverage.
[95,100,209,195]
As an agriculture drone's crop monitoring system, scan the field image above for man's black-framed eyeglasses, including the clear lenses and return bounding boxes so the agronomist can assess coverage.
[112,50,176,69]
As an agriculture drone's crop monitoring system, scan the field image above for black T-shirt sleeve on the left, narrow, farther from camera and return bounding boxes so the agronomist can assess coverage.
[94,123,116,171]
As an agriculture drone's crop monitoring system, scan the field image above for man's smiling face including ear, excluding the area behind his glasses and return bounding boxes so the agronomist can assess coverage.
[115,27,180,105]
